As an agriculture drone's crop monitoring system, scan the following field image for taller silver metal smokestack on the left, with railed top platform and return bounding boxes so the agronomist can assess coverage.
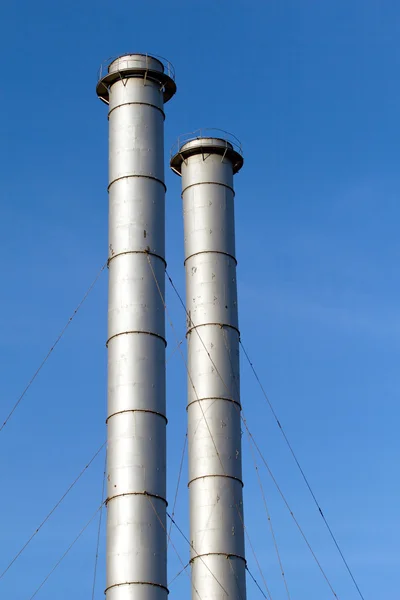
[96,54,176,600]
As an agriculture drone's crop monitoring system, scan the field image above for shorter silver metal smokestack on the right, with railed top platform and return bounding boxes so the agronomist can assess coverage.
[171,130,246,600]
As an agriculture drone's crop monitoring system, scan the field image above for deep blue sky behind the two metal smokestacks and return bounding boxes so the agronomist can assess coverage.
[0,0,400,600]
